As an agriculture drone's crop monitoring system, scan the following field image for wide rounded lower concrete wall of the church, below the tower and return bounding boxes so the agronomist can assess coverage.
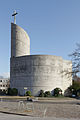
[10,55,72,95]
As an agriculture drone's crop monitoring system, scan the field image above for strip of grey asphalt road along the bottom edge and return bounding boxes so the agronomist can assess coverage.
[0,113,80,120]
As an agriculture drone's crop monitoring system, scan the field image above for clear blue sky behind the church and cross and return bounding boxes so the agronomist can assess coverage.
[0,0,80,75]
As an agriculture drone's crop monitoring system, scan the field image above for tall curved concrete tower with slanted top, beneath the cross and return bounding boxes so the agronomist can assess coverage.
[11,23,30,57]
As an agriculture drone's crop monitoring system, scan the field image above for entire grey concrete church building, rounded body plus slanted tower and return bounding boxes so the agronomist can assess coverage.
[10,23,72,96]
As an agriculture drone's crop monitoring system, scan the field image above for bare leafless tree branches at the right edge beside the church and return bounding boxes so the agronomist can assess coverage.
[61,43,80,78]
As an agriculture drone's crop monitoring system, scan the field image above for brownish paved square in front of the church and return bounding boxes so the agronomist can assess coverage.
[0,99,80,120]
